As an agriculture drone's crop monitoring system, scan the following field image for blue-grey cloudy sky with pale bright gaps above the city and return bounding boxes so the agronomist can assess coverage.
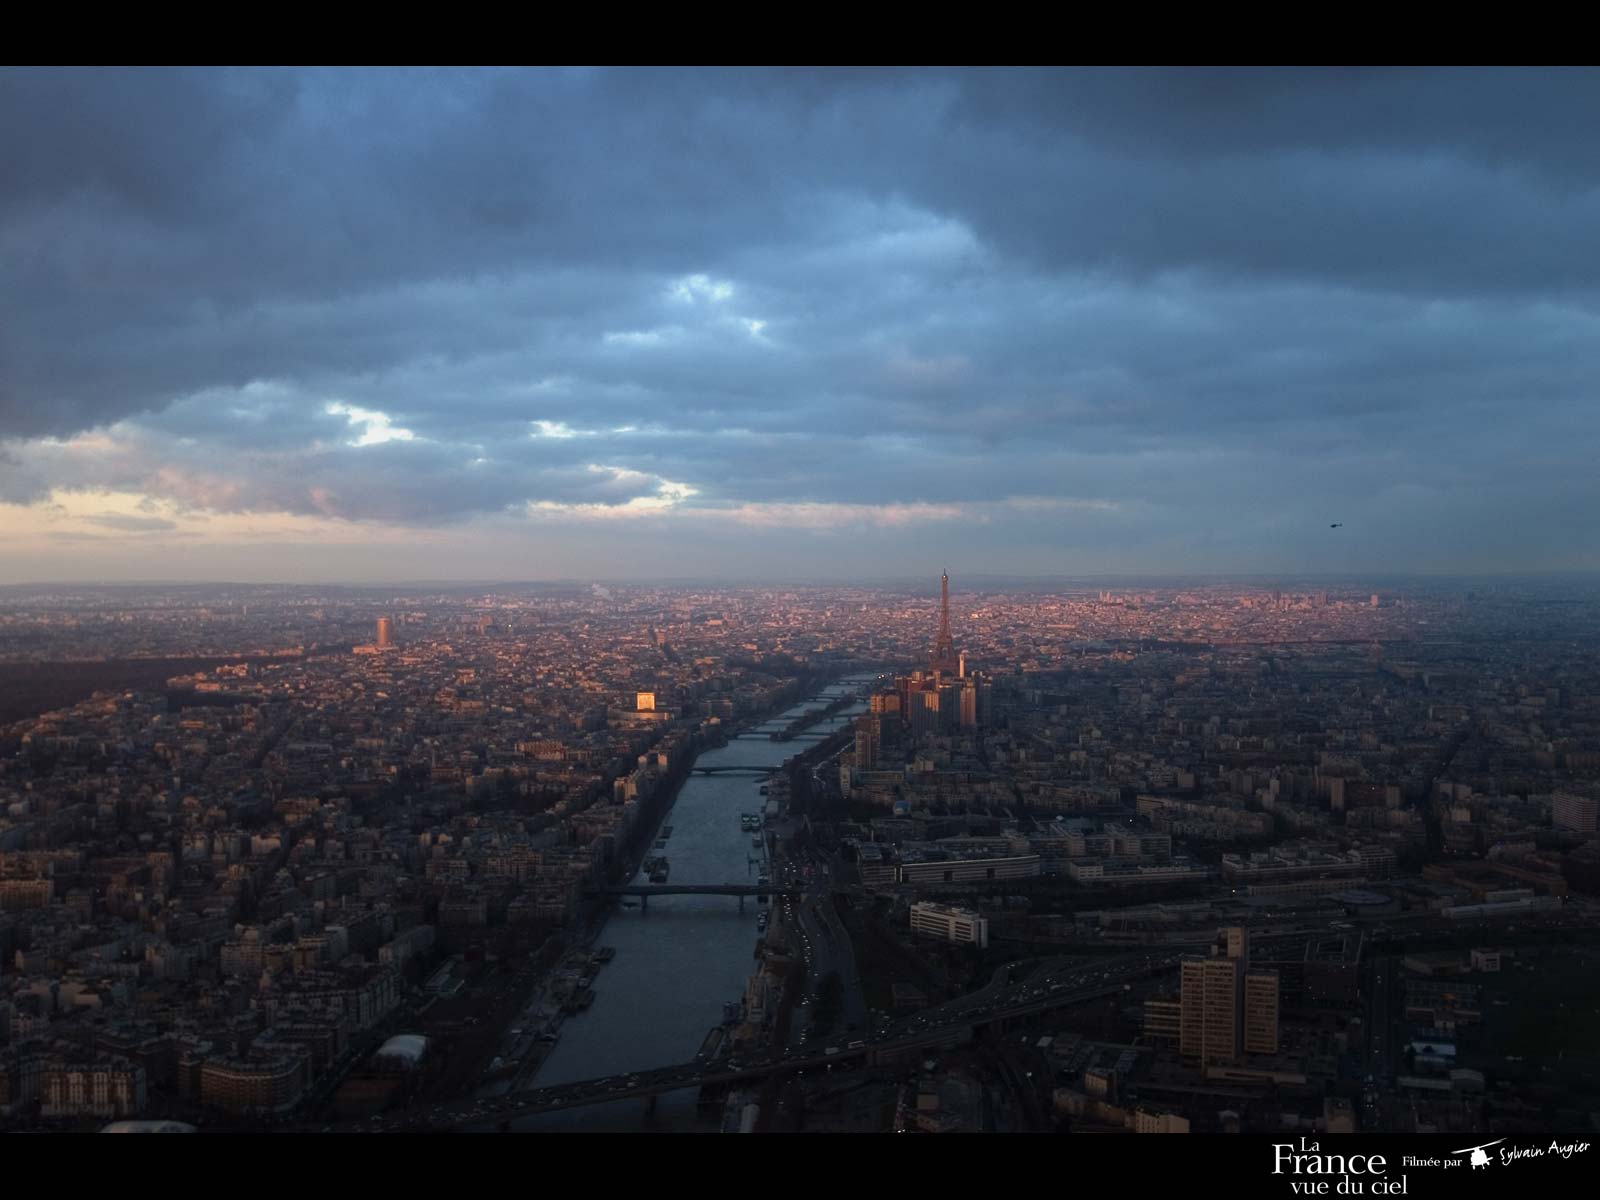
[0,70,1600,582]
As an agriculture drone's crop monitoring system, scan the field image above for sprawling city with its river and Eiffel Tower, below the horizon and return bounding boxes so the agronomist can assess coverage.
[0,562,1600,1146]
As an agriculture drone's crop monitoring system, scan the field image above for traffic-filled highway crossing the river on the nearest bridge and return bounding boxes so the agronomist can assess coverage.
[368,954,1179,1133]
